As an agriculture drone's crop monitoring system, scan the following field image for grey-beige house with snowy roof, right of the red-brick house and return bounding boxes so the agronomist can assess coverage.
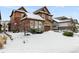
[54,16,75,31]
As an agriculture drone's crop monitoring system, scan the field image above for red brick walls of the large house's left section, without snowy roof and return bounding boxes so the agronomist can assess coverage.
[10,8,44,31]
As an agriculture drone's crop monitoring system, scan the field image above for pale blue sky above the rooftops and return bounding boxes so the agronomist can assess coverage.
[0,6,79,21]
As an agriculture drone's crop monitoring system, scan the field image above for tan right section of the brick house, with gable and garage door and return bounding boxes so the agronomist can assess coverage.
[34,6,53,31]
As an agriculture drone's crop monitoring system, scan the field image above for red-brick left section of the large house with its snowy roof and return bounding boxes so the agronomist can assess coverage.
[10,7,45,31]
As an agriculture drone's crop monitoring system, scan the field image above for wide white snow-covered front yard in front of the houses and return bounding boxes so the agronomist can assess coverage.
[0,31,79,53]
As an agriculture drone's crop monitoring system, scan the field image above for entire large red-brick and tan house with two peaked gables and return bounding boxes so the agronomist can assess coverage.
[10,7,52,31]
